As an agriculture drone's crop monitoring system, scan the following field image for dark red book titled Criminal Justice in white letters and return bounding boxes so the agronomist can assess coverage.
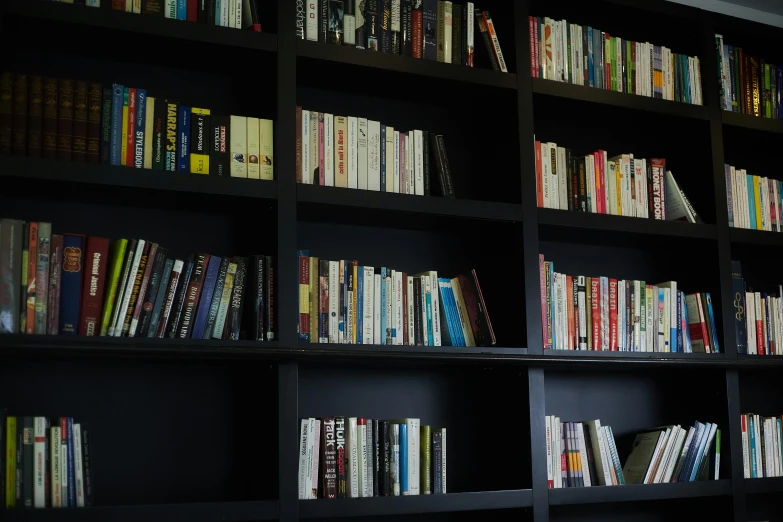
[79,236,109,337]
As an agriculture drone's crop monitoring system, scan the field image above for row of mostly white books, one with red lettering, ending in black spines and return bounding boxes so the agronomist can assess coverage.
[296,107,455,198]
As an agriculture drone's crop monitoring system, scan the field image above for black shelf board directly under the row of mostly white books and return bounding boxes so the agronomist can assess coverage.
[296,184,522,222]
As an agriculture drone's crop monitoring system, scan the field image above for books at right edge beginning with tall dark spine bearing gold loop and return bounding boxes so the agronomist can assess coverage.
[731,261,783,355]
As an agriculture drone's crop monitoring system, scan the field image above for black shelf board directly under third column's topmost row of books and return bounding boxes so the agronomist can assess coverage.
[532,78,710,120]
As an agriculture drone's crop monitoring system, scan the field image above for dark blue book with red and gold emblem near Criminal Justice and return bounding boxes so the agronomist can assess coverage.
[60,235,84,335]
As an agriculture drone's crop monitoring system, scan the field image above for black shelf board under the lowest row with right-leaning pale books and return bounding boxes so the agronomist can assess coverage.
[549,480,732,506]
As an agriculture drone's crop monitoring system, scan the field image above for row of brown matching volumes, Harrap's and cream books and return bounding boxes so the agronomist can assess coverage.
[0,72,274,179]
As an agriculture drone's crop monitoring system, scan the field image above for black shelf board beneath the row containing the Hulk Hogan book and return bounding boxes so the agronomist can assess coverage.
[299,489,533,519]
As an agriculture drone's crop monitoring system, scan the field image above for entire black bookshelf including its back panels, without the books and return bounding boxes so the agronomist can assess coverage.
[0,0,783,522]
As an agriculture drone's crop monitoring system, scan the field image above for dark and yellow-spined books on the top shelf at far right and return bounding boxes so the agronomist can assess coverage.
[715,34,783,120]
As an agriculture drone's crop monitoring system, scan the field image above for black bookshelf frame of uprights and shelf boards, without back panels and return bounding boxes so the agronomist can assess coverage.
[0,0,783,522]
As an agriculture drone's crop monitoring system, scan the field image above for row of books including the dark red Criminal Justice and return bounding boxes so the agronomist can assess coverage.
[0,219,275,341]
